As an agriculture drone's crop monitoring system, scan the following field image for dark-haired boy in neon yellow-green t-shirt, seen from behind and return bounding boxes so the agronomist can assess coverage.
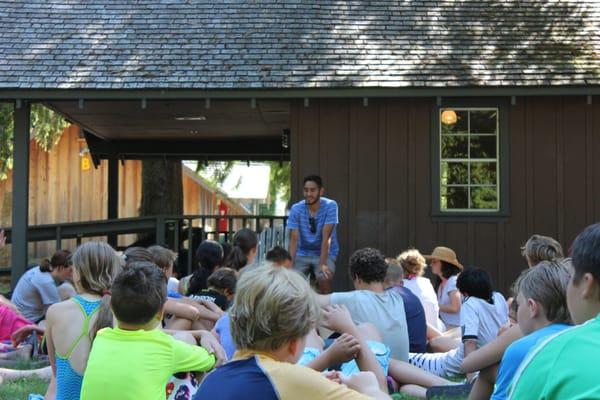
[81,261,216,400]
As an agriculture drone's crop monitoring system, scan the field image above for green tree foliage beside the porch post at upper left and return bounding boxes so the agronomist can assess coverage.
[0,103,68,180]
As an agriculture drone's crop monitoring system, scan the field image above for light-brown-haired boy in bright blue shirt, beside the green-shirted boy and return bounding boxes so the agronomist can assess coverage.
[491,261,571,400]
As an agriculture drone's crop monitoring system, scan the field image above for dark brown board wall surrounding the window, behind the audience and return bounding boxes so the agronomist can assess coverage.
[291,97,600,290]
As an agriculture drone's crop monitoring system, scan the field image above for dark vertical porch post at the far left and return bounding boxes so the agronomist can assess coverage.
[10,101,31,289]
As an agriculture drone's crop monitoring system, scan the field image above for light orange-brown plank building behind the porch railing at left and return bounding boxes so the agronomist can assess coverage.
[0,125,247,265]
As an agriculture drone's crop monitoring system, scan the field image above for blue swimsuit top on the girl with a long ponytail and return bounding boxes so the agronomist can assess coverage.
[55,296,100,400]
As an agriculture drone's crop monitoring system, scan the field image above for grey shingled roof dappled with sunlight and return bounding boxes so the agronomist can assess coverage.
[0,0,600,89]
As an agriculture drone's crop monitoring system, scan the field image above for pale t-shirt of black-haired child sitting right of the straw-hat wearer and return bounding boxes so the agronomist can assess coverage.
[444,292,508,374]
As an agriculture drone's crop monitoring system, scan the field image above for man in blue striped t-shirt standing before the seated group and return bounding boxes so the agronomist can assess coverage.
[287,175,339,294]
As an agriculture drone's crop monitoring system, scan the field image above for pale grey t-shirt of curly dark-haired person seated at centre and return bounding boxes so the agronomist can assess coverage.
[330,290,409,361]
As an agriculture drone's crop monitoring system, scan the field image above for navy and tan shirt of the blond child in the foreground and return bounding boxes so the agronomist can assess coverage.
[194,352,370,400]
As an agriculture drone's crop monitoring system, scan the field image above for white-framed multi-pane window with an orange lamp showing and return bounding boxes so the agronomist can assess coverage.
[439,107,500,212]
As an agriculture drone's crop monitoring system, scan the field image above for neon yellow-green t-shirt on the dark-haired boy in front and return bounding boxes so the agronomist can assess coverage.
[81,328,216,400]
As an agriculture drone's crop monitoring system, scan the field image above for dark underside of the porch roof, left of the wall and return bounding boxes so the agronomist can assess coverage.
[46,100,290,142]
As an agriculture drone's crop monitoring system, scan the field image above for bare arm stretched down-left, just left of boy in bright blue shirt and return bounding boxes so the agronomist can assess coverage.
[461,325,523,372]
